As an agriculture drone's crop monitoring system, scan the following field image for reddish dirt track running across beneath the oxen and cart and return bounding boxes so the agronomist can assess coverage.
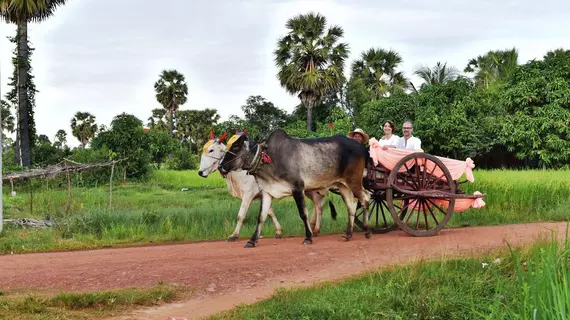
[0,222,566,319]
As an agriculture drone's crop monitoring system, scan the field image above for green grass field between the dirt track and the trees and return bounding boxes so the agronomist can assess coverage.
[0,170,570,253]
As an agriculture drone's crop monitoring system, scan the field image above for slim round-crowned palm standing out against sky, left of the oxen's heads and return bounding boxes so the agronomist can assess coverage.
[154,70,188,136]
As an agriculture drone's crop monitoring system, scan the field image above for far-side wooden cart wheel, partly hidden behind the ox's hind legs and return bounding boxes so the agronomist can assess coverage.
[354,190,406,234]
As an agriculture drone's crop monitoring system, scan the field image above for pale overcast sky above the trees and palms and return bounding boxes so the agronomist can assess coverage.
[0,0,570,146]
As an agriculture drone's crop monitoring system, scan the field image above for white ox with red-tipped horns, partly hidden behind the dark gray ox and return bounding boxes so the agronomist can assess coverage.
[198,132,336,241]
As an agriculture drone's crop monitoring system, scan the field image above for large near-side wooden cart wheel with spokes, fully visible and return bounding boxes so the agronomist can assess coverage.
[386,152,457,237]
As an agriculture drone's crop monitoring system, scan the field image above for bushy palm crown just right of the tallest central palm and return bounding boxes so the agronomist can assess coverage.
[352,48,410,99]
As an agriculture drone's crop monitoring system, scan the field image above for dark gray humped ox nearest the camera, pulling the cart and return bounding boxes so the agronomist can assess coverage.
[218,129,371,247]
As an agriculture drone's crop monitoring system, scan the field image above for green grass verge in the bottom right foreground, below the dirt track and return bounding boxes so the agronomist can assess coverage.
[208,228,570,320]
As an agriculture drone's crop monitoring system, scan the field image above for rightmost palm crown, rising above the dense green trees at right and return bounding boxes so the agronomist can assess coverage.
[463,48,518,88]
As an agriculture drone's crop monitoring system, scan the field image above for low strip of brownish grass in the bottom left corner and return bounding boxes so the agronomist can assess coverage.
[0,284,191,320]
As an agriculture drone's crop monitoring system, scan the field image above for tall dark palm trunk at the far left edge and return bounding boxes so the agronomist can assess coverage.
[18,21,30,168]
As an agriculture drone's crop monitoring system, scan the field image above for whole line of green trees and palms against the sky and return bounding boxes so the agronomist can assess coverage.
[0,6,570,178]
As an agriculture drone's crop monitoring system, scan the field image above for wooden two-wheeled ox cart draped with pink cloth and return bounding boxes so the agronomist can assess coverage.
[346,138,485,237]
